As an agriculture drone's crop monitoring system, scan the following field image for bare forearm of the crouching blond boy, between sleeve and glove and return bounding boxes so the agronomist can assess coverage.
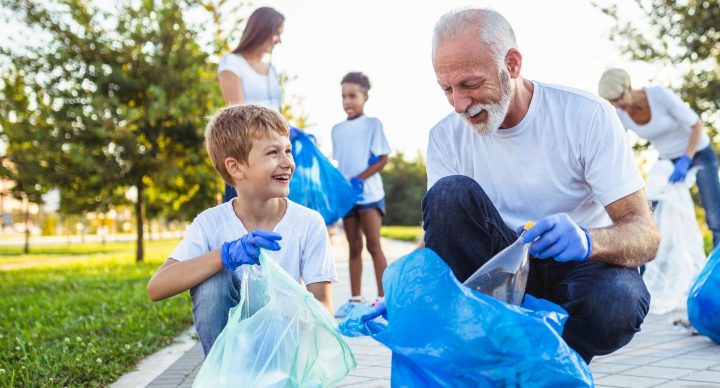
[147,249,223,302]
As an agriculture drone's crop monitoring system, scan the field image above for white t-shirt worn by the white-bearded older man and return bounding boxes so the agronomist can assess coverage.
[427,82,644,230]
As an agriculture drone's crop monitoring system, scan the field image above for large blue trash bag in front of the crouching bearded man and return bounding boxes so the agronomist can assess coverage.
[340,248,593,387]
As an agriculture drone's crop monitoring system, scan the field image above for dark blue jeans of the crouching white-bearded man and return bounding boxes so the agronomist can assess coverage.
[422,175,650,363]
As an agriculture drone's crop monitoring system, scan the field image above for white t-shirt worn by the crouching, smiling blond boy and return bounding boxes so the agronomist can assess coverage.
[170,198,337,284]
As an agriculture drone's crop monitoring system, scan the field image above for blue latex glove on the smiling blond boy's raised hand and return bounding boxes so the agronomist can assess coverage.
[220,229,282,271]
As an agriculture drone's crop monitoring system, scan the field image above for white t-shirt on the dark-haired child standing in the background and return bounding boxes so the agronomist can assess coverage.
[332,115,391,204]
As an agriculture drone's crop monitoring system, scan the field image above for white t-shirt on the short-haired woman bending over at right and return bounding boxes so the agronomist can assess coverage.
[617,86,710,159]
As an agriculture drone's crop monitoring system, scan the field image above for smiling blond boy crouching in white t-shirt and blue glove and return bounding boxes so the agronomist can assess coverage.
[148,105,337,355]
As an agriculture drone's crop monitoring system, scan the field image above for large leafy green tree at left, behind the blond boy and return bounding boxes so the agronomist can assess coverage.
[0,0,222,261]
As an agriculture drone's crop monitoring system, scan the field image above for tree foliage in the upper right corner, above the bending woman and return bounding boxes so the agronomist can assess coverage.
[600,0,720,137]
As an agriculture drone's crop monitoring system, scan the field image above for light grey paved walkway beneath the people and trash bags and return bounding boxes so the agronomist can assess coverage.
[114,235,720,388]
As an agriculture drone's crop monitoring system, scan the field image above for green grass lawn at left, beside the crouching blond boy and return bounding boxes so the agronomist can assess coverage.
[0,241,192,387]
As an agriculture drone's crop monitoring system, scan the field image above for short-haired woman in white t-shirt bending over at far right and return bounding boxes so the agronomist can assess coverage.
[598,69,720,246]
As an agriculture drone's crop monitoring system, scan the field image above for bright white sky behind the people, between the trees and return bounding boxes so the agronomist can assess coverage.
[248,0,658,156]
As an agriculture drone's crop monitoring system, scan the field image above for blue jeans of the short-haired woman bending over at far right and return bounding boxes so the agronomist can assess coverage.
[673,146,720,246]
